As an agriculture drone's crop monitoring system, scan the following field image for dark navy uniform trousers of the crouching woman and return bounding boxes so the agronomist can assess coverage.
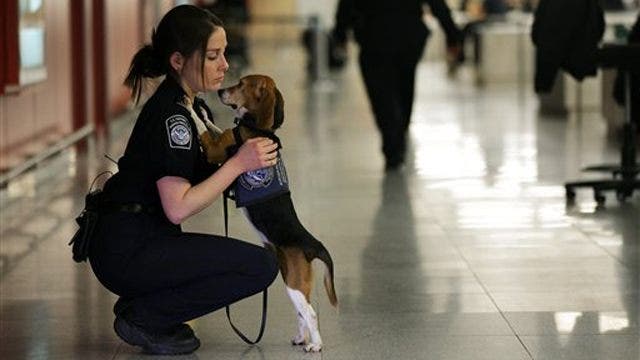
[89,213,278,330]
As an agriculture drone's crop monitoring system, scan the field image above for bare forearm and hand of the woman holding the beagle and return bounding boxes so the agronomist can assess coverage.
[156,138,278,224]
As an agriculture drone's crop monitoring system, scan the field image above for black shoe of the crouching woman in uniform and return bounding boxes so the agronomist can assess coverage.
[113,316,200,355]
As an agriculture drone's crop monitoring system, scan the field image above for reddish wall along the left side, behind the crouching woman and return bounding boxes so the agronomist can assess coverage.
[0,0,146,161]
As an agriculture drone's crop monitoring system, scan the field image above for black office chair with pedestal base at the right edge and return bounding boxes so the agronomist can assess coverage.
[564,44,640,208]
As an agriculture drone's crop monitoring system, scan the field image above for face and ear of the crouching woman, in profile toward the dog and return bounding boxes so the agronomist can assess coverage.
[181,27,229,95]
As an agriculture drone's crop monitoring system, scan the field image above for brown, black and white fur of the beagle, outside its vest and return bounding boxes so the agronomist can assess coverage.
[188,75,338,352]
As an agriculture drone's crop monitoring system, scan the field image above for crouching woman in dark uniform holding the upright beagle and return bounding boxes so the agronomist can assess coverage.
[89,5,277,354]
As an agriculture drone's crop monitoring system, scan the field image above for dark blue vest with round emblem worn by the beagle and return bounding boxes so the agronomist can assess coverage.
[234,153,289,207]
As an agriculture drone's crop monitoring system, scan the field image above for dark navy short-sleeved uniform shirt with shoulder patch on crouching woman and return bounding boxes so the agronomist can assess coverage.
[104,76,216,225]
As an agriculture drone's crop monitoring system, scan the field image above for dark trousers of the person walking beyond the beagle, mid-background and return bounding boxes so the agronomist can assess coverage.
[359,48,423,166]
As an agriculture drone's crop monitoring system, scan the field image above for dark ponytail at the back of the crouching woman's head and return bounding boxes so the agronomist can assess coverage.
[124,44,166,104]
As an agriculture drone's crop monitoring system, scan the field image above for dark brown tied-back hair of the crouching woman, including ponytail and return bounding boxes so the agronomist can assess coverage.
[124,5,223,103]
